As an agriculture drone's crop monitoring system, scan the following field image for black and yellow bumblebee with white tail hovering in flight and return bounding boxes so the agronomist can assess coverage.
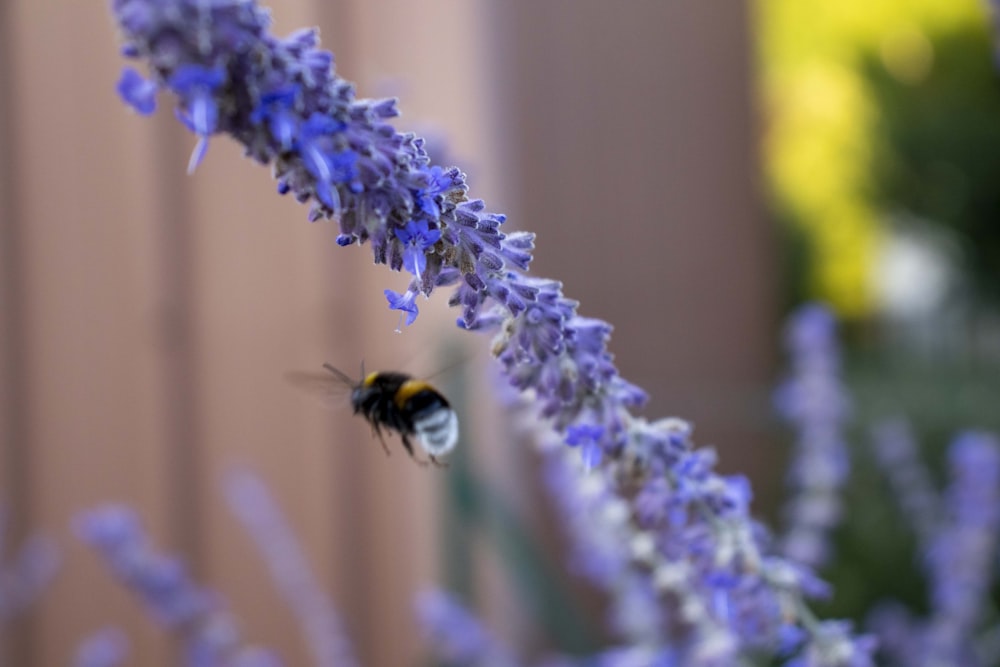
[288,364,458,467]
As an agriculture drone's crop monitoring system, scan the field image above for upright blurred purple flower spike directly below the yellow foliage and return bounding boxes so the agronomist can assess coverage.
[775,304,849,567]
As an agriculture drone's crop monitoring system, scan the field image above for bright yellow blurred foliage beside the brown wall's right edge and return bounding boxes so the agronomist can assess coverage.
[756,0,987,317]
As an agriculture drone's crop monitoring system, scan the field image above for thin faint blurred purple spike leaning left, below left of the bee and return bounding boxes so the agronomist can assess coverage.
[225,470,358,667]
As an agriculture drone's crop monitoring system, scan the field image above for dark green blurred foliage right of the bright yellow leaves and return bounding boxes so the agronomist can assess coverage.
[862,22,1000,304]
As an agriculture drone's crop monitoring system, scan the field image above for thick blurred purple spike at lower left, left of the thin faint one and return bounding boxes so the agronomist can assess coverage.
[76,505,281,667]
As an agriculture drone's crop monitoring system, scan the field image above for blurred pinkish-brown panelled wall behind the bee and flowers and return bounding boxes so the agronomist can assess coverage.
[0,0,777,667]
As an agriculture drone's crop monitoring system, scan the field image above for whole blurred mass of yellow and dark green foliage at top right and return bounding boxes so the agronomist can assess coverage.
[757,0,1000,318]
